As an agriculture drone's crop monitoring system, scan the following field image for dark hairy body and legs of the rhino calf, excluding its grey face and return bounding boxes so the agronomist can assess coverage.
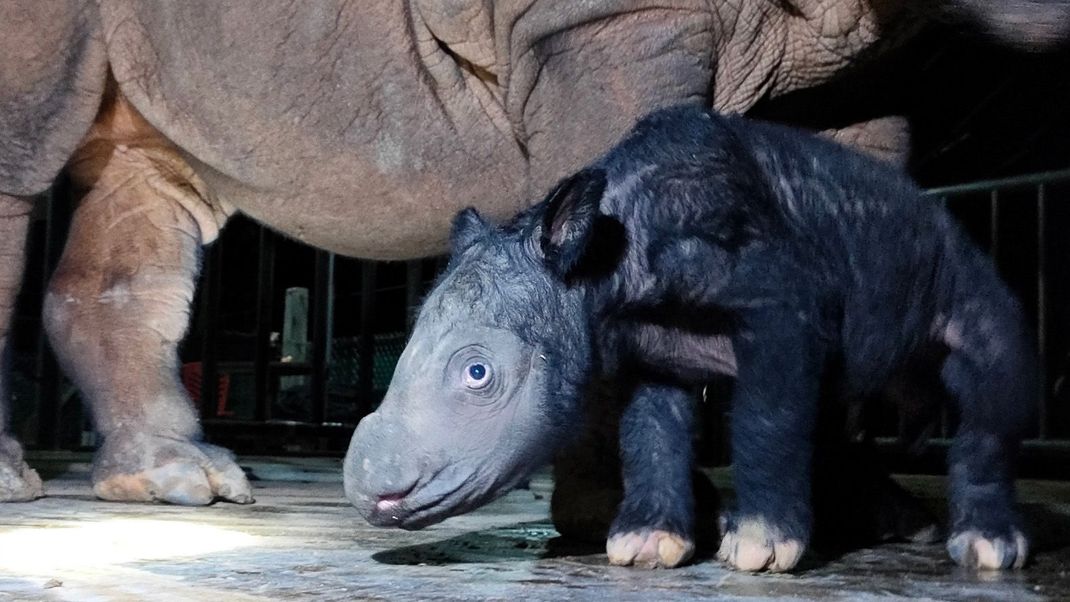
[464,107,1035,564]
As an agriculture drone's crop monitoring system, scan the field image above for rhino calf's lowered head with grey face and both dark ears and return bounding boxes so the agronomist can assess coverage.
[343,171,606,529]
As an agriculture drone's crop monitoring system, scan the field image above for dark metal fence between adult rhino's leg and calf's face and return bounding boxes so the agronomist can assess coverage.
[181,222,437,453]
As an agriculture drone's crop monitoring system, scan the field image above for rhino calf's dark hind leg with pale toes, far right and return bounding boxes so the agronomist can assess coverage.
[941,292,1037,570]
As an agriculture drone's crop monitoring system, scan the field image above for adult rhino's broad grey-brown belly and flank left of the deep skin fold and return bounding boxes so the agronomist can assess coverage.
[102,2,531,259]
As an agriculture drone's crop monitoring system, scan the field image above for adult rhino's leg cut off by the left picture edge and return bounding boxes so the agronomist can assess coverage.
[0,195,44,501]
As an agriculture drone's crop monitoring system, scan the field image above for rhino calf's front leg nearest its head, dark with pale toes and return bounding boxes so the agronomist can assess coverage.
[606,383,694,569]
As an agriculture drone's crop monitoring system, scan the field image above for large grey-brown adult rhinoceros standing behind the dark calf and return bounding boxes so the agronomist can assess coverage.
[0,0,1066,505]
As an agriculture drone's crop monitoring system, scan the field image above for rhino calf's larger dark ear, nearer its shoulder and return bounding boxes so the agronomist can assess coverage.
[539,169,606,278]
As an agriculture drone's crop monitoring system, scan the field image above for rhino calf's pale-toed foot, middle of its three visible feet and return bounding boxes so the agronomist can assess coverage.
[717,516,806,572]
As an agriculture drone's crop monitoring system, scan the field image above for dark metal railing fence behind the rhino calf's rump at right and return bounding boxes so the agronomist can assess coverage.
[880,169,1070,478]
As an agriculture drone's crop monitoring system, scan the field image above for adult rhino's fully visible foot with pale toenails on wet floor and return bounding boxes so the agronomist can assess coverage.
[93,431,254,506]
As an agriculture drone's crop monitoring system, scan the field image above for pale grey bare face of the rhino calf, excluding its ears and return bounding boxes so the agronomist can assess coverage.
[345,261,585,529]
